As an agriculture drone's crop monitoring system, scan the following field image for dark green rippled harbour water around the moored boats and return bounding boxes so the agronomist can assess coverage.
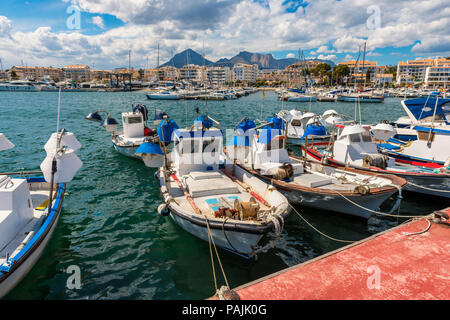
[0,92,448,299]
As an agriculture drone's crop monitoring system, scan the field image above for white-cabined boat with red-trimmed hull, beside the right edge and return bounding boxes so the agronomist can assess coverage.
[302,123,450,198]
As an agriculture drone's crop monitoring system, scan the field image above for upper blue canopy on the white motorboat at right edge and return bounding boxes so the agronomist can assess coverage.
[402,95,450,125]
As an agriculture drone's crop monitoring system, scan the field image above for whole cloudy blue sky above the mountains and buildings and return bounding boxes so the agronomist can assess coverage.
[0,0,450,69]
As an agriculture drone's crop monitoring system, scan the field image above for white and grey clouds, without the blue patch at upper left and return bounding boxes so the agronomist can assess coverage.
[0,0,450,67]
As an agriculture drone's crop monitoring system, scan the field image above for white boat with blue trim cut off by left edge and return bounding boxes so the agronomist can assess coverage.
[0,129,82,298]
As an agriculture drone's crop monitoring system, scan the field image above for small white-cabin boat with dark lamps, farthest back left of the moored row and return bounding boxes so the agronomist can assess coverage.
[86,104,177,168]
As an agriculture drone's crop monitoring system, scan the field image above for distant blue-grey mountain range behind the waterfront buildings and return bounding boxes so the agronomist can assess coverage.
[161,49,335,69]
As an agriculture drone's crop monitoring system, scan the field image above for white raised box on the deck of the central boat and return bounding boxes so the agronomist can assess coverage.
[185,173,239,198]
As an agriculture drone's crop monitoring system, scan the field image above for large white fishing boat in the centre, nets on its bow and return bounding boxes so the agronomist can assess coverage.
[156,116,289,258]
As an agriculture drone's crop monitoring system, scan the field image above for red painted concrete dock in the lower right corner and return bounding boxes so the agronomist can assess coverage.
[234,208,450,300]
